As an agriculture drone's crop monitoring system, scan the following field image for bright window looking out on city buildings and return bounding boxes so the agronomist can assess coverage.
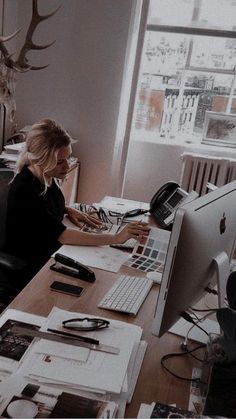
[131,0,236,144]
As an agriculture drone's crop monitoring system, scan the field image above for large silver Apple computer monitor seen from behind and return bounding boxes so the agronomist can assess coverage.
[152,181,236,337]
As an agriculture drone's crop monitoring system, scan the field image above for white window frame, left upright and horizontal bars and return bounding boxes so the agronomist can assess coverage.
[111,0,236,196]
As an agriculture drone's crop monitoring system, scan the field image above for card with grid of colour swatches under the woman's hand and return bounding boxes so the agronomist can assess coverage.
[124,227,170,272]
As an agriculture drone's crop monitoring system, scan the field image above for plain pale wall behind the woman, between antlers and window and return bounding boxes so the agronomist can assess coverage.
[6,0,133,202]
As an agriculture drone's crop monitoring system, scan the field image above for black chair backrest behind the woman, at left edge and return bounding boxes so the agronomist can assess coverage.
[0,168,14,249]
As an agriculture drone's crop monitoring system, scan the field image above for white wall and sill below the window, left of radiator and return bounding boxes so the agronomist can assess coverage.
[123,141,236,202]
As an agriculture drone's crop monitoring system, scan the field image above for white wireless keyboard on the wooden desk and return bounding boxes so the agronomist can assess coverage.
[98,275,153,316]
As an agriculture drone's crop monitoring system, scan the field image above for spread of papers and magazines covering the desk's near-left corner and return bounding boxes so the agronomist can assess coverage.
[0,307,147,419]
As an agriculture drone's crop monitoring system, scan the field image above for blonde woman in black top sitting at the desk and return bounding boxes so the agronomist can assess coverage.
[5,119,149,289]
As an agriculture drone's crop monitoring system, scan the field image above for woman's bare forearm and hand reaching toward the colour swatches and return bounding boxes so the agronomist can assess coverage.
[58,222,150,246]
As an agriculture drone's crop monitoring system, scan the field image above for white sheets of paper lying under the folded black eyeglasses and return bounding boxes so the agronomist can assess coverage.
[24,308,142,393]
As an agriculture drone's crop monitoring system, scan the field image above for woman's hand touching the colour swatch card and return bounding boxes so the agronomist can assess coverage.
[112,222,150,244]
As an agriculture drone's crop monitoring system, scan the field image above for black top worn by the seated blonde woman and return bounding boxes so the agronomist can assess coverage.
[5,166,66,279]
